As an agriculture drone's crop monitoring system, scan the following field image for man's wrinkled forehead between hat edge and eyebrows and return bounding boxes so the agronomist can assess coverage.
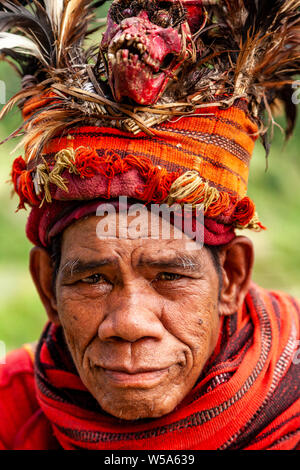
[62,208,203,255]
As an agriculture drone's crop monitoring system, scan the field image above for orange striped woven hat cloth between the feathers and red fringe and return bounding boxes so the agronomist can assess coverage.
[19,100,258,199]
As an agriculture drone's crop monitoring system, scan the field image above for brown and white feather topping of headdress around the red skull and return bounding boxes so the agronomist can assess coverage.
[0,0,300,159]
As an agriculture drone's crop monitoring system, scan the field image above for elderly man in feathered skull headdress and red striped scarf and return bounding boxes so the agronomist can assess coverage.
[0,0,300,450]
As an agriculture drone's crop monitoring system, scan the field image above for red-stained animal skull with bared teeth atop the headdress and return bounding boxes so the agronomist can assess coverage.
[101,0,198,105]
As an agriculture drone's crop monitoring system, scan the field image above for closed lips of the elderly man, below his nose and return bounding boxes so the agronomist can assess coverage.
[100,367,169,389]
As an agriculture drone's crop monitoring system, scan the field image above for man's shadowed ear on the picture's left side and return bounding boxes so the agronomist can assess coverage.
[29,247,59,324]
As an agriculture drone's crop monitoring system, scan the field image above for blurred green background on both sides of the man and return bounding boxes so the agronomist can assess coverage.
[0,9,300,351]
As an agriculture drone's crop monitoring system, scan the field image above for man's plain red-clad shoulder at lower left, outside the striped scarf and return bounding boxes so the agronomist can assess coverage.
[0,345,39,449]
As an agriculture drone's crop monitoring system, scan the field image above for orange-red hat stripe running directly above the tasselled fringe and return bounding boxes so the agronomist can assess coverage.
[44,130,249,197]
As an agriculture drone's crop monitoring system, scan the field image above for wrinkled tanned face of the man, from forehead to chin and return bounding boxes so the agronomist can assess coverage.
[56,209,219,420]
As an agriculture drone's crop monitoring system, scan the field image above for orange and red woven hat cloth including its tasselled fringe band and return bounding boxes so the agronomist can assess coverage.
[12,101,263,246]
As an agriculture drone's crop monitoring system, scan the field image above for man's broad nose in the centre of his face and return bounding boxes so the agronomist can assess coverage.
[98,280,164,343]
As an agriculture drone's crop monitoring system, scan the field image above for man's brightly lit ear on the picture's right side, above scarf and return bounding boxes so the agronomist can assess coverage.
[219,237,254,315]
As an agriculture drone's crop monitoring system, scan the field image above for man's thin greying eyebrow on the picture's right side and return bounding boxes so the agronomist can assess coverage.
[138,255,202,272]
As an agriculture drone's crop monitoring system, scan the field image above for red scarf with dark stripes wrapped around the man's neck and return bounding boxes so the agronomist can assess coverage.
[35,285,300,450]
